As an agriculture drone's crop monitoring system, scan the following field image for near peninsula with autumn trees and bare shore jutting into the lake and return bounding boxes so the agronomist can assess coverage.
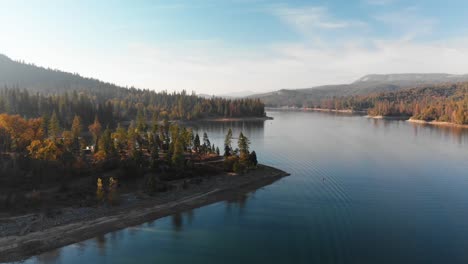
[0,121,288,262]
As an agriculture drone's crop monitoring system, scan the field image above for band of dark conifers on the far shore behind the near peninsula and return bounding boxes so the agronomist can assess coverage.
[0,87,265,127]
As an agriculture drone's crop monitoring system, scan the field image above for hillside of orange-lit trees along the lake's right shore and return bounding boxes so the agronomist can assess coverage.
[315,82,468,124]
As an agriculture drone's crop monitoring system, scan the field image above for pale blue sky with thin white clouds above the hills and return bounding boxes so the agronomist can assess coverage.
[0,0,468,95]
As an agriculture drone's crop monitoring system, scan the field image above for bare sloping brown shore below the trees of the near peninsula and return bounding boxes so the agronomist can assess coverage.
[0,165,289,262]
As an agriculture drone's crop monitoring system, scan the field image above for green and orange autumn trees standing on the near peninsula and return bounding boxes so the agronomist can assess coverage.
[0,110,257,192]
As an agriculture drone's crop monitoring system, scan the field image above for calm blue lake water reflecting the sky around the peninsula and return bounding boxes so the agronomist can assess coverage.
[25,111,468,264]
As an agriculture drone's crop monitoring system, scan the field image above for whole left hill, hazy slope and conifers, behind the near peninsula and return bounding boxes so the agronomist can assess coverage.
[0,55,265,126]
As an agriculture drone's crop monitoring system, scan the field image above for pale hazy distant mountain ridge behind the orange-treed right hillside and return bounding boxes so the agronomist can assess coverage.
[248,73,468,107]
